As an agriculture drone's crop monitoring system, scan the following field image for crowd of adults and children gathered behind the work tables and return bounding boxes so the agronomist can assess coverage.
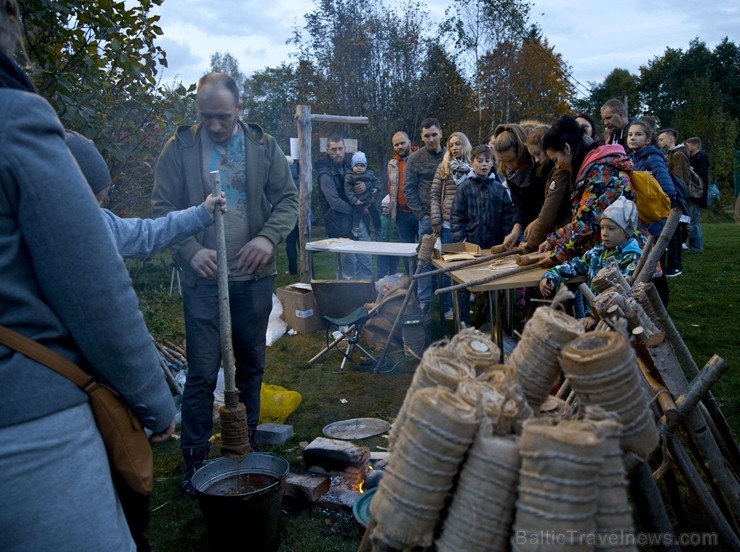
[316,99,708,322]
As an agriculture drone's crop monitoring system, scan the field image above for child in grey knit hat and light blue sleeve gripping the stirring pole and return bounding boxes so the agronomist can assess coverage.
[64,130,226,259]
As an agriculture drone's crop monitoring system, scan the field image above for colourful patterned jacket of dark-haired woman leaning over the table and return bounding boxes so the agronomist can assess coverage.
[547,144,634,264]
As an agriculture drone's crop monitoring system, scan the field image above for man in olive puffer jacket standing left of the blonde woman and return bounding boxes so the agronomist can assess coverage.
[403,118,446,312]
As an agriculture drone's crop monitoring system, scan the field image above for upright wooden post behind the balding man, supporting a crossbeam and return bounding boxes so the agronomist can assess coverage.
[295,105,313,283]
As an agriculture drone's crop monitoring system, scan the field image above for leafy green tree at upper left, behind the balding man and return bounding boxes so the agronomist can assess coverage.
[22,0,192,214]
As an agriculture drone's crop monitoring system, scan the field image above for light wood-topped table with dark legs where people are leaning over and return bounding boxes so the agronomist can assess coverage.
[432,255,546,363]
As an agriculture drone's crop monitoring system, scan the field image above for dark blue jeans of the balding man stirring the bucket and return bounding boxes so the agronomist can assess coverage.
[180,276,275,449]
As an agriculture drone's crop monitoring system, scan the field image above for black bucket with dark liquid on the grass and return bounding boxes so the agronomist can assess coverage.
[192,452,290,552]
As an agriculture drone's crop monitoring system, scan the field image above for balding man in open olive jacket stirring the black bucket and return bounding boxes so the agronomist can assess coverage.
[152,73,298,498]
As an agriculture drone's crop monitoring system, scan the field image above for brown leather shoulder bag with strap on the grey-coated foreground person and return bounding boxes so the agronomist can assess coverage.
[0,326,154,495]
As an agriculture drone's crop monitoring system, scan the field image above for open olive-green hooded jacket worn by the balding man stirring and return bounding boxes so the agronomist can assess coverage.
[152,121,298,286]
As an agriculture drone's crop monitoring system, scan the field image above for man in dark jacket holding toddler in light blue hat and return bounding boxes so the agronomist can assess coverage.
[314,134,373,280]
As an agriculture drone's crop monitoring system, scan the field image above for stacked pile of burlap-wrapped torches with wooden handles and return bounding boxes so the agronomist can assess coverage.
[358,267,740,552]
